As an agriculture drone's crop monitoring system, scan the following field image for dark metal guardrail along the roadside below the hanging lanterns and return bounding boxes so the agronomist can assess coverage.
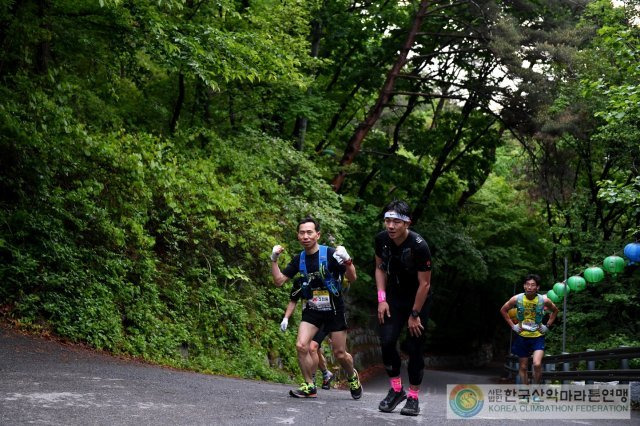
[504,347,640,383]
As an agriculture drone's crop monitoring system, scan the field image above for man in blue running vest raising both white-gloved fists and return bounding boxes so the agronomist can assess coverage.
[271,218,362,399]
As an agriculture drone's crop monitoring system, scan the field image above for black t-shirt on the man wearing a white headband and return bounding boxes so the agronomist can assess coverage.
[375,230,431,300]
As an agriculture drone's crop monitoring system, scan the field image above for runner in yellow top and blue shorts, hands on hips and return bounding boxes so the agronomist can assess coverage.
[500,274,558,385]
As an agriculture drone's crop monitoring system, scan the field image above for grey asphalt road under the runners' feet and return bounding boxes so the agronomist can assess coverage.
[0,326,640,426]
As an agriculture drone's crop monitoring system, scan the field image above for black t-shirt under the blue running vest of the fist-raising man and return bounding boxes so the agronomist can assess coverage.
[282,247,346,310]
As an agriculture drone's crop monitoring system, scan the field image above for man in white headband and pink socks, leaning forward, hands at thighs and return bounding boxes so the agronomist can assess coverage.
[375,201,431,416]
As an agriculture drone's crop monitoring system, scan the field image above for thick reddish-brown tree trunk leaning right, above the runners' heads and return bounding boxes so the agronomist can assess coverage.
[332,0,429,192]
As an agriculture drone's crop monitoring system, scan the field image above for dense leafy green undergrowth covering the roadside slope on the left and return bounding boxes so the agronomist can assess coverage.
[0,75,344,380]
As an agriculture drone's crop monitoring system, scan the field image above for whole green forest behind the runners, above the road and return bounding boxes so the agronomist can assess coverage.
[0,0,640,381]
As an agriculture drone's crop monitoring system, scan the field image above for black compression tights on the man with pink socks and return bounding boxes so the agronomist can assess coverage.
[380,308,426,386]
